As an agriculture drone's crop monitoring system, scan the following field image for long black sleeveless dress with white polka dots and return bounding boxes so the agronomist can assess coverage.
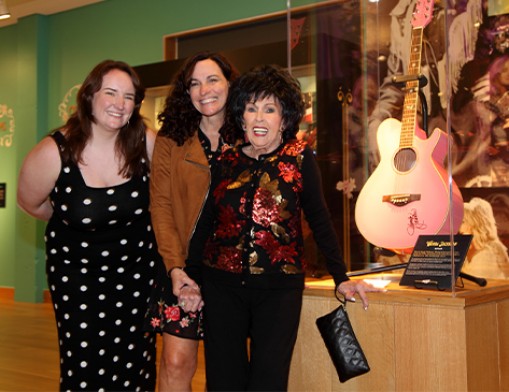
[45,132,160,391]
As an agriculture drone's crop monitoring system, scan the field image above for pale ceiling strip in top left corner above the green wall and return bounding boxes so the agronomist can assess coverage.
[0,0,104,28]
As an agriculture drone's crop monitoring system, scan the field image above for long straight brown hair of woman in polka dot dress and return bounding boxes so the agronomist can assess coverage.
[59,60,149,178]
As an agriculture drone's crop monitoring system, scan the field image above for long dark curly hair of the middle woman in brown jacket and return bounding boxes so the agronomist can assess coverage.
[157,51,239,146]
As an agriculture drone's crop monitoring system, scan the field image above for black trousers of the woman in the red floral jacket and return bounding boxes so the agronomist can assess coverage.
[202,279,302,391]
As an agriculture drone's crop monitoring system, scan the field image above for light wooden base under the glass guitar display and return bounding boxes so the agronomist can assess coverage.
[289,274,509,392]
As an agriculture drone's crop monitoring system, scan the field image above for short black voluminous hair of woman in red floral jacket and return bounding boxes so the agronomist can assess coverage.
[227,65,305,141]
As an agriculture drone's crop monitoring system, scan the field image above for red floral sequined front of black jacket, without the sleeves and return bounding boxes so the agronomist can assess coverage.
[199,141,307,273]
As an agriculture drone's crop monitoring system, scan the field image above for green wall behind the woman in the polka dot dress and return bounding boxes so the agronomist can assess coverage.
[0,0,320,302]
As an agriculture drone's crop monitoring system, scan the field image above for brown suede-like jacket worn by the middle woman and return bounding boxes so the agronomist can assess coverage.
[150,133,210,271]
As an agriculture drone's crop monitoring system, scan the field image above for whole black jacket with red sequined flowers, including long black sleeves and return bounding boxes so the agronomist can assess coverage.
[190,140,348,285]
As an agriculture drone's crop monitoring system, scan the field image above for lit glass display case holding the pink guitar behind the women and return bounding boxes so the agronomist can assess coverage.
[133,0,509,287]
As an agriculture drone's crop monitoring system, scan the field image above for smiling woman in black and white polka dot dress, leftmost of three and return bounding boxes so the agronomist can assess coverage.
[18,60,161,391]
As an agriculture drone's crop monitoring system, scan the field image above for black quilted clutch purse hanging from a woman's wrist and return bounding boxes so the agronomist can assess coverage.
[316,292,370,382]
